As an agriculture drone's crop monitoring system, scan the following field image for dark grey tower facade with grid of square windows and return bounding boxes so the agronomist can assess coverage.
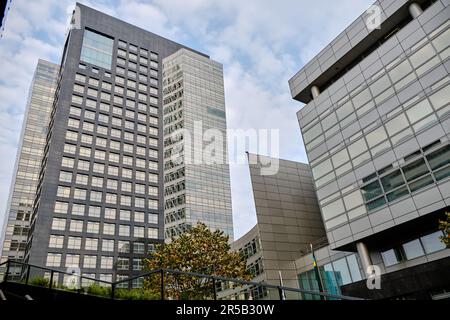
[26,4,212,286]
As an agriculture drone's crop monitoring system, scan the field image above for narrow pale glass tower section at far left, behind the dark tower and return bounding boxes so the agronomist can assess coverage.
[0,60,59,277]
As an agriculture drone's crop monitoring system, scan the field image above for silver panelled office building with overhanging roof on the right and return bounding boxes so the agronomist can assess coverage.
[289,0,450,297]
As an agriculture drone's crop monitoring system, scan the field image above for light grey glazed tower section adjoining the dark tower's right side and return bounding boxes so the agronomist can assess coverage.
[163,49,233,241]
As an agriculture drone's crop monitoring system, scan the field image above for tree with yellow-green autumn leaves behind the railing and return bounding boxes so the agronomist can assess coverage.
[144,223,251,299]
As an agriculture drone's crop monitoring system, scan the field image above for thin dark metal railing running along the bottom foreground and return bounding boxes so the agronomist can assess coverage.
[0,260,364,300]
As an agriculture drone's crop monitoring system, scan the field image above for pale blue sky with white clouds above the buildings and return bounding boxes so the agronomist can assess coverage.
[0,0,373,238]
